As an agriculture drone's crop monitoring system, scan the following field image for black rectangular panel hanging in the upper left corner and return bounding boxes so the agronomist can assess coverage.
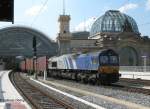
[0,0,14,23]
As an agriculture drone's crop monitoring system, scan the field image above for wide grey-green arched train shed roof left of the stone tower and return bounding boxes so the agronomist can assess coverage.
[0,26,58,57]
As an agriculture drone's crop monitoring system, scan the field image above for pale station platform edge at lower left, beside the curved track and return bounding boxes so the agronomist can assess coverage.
[0,71,31,109]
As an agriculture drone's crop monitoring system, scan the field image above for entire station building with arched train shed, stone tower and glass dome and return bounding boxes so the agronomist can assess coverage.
[0,10,150,66]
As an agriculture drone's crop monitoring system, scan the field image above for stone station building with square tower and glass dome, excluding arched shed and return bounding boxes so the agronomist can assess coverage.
[57,10,150,66]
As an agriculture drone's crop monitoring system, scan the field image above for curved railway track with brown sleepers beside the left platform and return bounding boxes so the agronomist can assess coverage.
[9,72,73,109]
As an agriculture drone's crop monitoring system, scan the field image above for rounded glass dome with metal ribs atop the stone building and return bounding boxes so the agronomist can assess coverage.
[90,10,139,36]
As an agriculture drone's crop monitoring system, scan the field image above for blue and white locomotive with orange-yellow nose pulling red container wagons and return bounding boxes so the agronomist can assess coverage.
[21,49,120,84]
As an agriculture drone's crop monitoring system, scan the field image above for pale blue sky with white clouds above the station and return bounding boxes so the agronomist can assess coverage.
[0,0,150,40]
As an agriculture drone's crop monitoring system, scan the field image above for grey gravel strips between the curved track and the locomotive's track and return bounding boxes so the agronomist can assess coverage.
[22,74,150,109]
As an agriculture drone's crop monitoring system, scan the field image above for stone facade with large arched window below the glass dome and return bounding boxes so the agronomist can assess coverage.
[90,32,150,66]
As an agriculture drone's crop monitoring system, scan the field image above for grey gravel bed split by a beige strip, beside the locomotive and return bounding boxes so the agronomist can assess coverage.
[40,79,149,109]
